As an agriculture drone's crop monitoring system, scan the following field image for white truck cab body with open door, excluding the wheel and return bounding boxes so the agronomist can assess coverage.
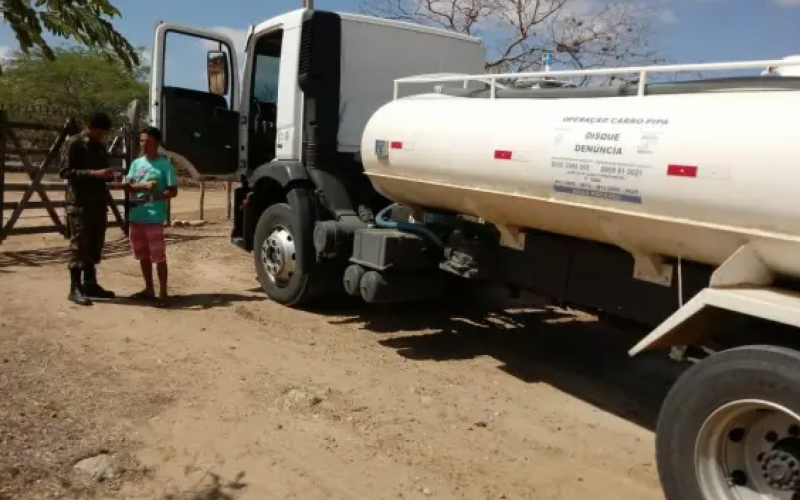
[150,9,484,179]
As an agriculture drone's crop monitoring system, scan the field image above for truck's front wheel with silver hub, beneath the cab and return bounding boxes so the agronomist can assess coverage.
[253,189,315,306]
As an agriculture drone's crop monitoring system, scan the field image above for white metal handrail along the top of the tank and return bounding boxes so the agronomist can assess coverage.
[394,59,800,99]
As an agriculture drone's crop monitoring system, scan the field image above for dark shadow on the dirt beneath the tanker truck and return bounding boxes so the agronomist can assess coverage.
[323,292,686,430]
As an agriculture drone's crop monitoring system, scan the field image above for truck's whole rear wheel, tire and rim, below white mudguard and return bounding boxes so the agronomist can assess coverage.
[656,346,800,500]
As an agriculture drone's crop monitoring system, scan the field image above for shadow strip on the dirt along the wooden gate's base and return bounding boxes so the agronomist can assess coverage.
[0,233,213,272]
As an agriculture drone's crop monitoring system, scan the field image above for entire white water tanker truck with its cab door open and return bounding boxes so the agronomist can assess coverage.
[150,9,800,500]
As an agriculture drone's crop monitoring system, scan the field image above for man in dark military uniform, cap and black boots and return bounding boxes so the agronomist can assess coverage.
[59,113,115,305]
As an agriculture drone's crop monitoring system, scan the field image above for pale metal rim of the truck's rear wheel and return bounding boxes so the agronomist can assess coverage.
[694,399,800,500]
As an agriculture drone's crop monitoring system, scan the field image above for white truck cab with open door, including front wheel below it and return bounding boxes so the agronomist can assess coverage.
[150,9,485,305]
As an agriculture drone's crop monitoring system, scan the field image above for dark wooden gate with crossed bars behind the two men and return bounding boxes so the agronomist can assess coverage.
[0,110,133,243]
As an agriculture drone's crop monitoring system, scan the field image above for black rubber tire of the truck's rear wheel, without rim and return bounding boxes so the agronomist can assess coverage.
[656,345,800,500]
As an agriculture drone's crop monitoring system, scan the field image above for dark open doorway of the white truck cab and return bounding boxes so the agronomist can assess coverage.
[248,30,283,167]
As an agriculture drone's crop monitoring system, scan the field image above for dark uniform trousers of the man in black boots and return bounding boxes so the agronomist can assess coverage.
[67,207,108,269]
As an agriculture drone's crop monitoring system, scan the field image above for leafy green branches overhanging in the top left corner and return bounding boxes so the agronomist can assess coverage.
[0,0,140,69]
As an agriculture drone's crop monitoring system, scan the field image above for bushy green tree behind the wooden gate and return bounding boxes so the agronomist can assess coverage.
[0,47,150,121]
